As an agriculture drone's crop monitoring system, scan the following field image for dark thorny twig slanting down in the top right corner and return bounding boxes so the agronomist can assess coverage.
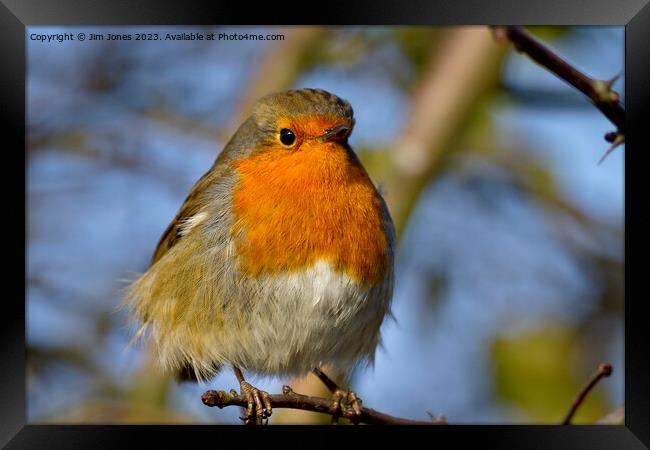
[493,26,625,135]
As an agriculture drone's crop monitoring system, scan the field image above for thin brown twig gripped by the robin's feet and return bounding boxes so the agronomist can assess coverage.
[201,386,447,425]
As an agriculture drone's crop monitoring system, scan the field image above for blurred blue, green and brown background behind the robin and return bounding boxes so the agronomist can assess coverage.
[26,27,625,424]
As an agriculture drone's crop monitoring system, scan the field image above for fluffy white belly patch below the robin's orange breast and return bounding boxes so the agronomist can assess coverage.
[229,261,389,374]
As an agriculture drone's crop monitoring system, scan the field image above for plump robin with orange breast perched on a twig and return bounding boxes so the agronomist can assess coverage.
[126,89,394,423]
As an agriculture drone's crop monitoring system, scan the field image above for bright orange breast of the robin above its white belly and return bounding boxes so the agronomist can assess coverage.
[232,128,389,286]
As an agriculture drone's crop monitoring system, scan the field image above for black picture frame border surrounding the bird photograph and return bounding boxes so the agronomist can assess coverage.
[0,0,650,449]
